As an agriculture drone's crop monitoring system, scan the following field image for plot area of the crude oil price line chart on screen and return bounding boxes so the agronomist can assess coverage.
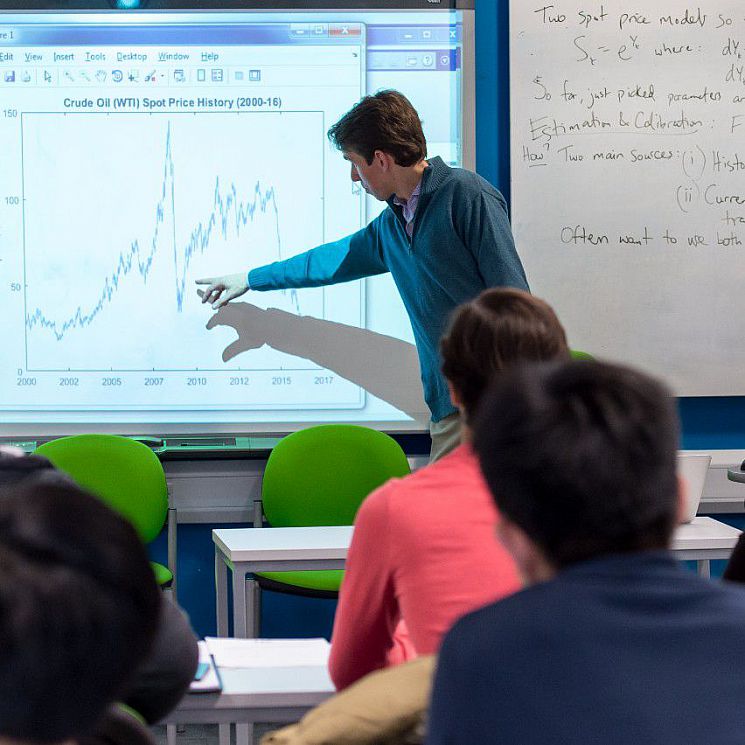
[18,111,354,370]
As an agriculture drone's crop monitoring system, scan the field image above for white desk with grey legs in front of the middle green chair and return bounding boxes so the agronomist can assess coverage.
[212,525,352,637]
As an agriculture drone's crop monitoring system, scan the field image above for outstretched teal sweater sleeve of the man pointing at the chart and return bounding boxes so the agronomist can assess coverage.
[248,217,388,290]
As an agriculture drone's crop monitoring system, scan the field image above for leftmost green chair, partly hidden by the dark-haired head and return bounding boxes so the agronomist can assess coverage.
[35,435,176,597]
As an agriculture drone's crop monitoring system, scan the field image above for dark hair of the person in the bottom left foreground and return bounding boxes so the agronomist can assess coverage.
[0,474,161,743]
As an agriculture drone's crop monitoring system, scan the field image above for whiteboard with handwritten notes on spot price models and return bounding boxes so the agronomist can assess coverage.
[510,0,745,396]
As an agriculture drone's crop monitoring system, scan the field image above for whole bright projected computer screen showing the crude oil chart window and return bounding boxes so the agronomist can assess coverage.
[0,11,460,435]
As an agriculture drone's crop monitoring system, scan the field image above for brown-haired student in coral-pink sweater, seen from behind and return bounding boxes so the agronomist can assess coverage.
[329,289,569,688]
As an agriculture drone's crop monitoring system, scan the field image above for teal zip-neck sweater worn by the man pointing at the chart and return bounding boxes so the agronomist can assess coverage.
[248,158,528,422]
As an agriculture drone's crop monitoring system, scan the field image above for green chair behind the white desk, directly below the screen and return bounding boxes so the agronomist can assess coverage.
[247,424,411,634]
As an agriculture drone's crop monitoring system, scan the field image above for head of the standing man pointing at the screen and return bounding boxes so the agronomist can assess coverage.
[328,90,427,200]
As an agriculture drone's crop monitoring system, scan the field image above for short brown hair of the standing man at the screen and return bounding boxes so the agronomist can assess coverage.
[328,90,427,166]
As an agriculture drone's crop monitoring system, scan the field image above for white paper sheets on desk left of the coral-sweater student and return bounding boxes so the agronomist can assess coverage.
[205,636,331,668]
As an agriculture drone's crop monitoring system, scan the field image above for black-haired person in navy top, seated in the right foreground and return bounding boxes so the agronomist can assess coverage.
[428,362,745,745]
